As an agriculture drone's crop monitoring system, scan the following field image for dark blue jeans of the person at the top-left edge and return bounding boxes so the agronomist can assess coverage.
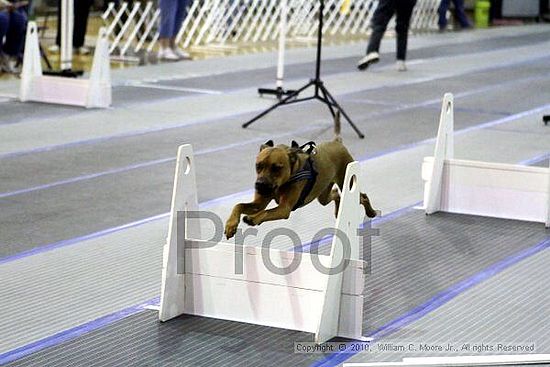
[0,10,27,56]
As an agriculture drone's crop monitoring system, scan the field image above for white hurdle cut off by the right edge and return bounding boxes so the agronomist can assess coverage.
[422,93,550,227]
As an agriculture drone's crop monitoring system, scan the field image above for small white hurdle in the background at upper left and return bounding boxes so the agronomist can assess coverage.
[19,22,111,108]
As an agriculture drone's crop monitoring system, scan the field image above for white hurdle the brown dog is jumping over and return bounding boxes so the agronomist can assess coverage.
[159,145,365,343]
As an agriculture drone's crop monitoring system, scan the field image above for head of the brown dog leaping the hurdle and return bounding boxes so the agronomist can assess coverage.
[255,140,299,196]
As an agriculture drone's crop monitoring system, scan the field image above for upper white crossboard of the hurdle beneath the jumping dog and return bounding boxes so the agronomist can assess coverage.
[185,240,364,295]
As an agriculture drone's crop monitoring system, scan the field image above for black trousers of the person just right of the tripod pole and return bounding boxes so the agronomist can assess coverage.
[367,0,416,60]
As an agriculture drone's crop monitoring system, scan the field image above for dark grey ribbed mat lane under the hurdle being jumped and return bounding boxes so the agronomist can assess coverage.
[8,210,550,366]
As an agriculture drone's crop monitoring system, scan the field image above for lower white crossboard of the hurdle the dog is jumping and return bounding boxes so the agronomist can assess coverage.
[185,274,363,336]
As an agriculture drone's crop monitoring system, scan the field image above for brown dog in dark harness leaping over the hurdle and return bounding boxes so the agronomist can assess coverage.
[225,119,376,239]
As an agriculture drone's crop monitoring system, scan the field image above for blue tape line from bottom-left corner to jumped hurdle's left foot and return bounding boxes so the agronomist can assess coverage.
[0,297,160,365]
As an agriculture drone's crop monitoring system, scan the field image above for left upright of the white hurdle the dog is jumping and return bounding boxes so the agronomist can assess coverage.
[159,144,200,321]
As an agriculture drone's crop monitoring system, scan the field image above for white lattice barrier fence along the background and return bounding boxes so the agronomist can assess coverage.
[101,0,440,56]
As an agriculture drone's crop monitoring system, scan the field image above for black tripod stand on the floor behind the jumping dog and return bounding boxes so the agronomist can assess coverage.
[243,0,365,139]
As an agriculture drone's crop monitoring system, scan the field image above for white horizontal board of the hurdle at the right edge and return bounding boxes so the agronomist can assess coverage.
[422,157,550,223]
